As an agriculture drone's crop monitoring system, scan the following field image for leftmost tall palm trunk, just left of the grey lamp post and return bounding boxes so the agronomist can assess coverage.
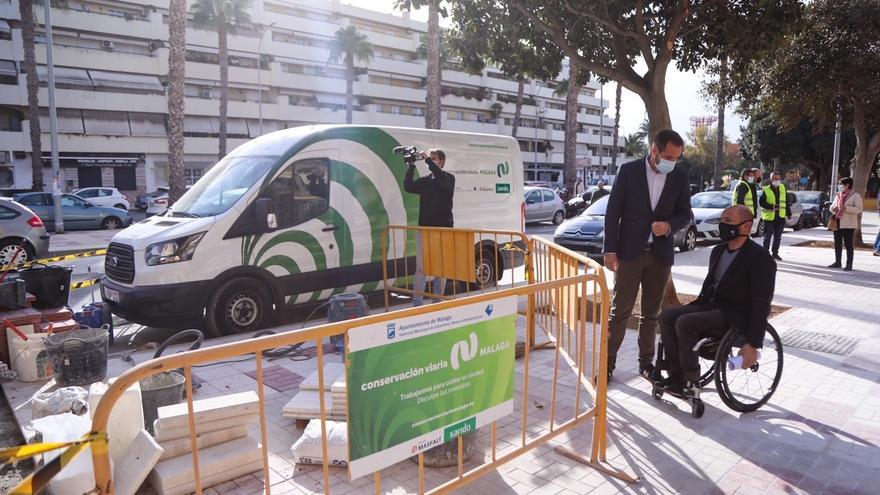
[18,0,44,191]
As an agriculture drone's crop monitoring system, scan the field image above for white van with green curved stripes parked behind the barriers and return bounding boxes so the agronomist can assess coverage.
[101,125,523,335]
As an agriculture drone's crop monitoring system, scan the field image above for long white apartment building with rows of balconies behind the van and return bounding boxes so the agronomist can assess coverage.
[0,0,623,195]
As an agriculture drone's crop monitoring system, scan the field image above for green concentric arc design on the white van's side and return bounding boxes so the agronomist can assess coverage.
[241,127,418,303]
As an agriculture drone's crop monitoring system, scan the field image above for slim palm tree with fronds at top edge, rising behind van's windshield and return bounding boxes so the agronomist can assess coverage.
[190,0,251,158]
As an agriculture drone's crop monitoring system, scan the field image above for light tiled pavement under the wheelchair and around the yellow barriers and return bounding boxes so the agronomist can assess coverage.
[6,214,880,495]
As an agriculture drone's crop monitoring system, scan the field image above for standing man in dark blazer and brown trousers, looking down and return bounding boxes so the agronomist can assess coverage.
[605,130,693,378]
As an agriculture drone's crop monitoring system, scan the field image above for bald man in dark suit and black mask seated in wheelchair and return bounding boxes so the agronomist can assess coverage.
[660,205,776,394]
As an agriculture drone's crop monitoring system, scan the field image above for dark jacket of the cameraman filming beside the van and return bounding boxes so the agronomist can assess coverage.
[403,158,455,227]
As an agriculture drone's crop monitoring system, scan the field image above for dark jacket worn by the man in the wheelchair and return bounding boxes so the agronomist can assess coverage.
[691,239,776,348]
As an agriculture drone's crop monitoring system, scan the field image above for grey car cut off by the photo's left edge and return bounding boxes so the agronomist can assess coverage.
[0,198,49,265]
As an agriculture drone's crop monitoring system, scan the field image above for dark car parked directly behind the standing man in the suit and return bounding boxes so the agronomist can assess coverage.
[553,196,697,259]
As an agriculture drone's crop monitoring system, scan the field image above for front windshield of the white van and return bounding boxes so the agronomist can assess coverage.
[171,156,278,217]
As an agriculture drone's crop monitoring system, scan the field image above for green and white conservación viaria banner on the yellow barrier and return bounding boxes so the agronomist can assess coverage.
[347,297,517,478]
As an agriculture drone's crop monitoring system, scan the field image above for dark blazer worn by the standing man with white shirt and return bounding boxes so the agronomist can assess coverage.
[605,158,693,265]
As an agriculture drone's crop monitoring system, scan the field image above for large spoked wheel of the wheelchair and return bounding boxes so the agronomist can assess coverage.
[715,324,782,412]
